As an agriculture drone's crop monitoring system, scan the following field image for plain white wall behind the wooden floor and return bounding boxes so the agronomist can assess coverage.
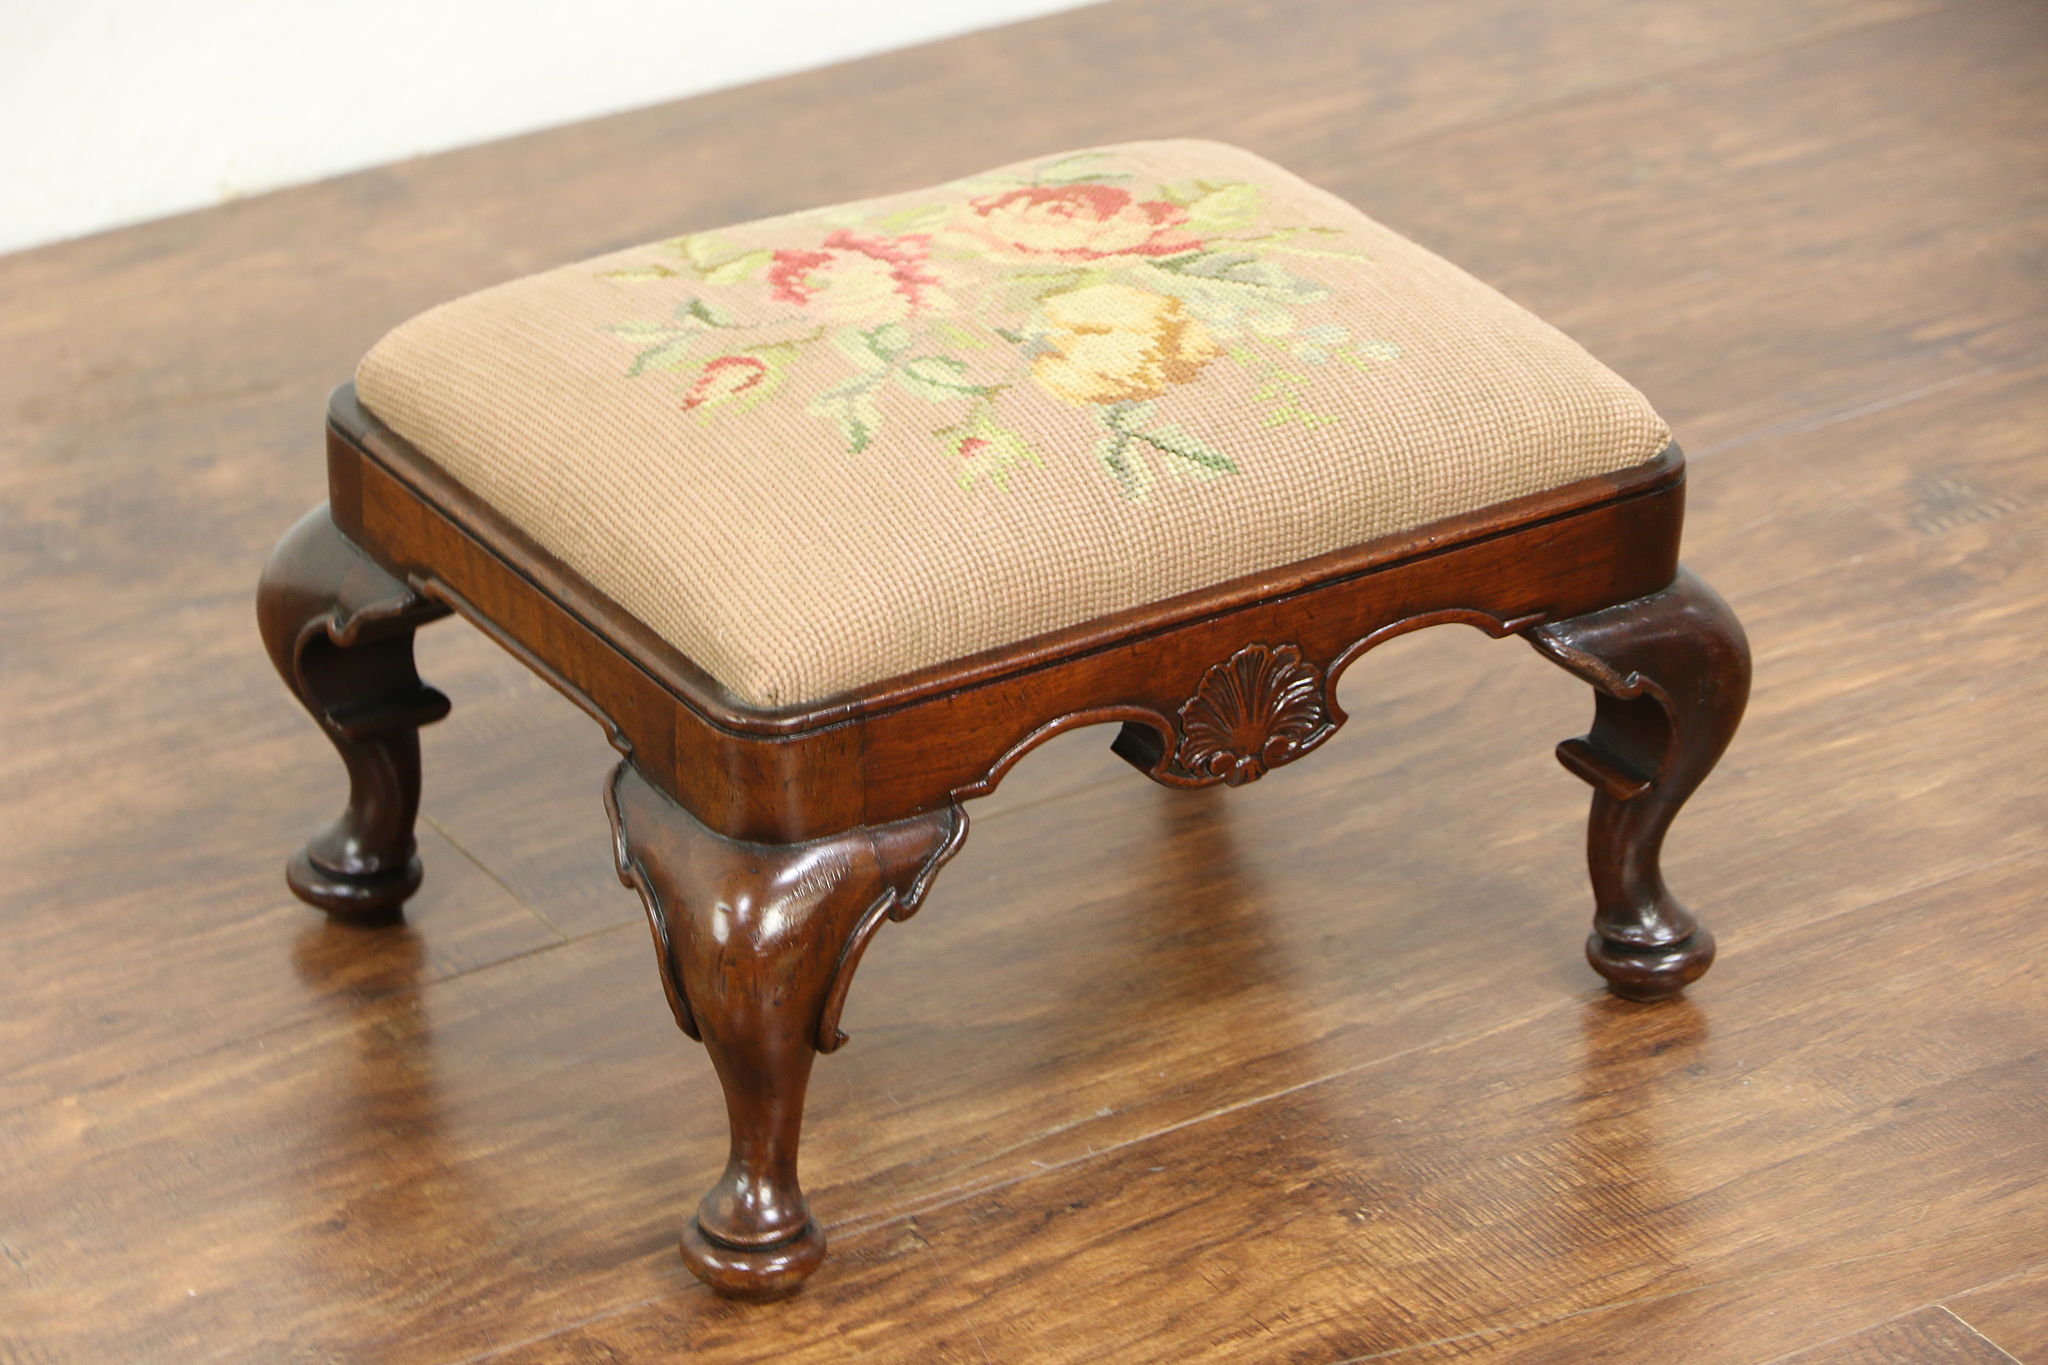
[0,0,1087,252]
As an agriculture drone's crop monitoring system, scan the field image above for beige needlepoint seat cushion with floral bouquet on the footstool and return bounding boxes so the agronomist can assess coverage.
[356,141,1669,706]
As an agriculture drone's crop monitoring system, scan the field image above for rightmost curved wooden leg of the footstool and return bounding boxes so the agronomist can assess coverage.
[1526,569,1749,1001]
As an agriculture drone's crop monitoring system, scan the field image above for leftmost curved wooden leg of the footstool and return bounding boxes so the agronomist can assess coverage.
[256,505,449,919]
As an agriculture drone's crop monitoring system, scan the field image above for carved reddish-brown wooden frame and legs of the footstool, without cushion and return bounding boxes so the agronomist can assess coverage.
[258,387,1749,1297]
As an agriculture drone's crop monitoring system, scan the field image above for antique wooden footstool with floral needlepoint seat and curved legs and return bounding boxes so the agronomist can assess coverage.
[258,141,1749,1297]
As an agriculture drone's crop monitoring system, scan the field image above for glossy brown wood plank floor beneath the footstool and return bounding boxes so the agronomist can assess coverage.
[0,0,2048,1365]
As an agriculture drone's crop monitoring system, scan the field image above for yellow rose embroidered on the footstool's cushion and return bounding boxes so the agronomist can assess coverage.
[1032,284,1223,407]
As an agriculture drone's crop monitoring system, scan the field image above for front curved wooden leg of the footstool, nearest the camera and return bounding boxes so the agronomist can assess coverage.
[606,763,967,1297]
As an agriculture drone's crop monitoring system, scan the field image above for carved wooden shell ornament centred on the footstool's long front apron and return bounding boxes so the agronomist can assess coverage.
[1176,645,1337,786]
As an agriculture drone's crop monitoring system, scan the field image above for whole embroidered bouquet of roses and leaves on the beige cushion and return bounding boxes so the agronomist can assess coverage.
[604,153,1401,501]
